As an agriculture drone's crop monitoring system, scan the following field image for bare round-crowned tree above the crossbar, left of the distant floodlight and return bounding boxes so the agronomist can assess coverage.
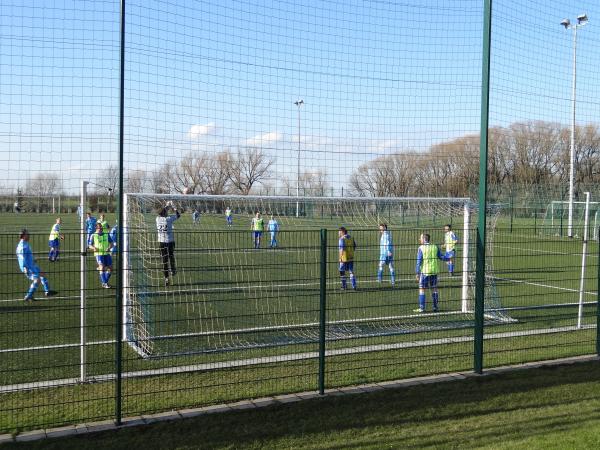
[229,147,273,195]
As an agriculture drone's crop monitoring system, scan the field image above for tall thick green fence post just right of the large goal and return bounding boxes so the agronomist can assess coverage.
[473,0,492,373]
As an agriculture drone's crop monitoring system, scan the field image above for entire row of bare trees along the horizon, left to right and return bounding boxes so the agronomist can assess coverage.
[12,121,600,203]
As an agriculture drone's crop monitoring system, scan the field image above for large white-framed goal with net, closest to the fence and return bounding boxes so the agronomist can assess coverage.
[123,194,512,357]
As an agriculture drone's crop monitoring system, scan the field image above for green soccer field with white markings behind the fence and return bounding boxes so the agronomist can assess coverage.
[0,214,598,430]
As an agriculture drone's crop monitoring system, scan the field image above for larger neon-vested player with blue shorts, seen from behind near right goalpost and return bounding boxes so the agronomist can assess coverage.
[414,233,447,313]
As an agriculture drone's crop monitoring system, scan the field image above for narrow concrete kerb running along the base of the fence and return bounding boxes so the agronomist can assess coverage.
[8,355,600,444]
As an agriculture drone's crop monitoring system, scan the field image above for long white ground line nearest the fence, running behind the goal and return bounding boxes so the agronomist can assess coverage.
[0,325,596,393]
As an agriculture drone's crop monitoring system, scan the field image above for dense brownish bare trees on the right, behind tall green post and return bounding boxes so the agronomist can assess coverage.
[350,121,600,197]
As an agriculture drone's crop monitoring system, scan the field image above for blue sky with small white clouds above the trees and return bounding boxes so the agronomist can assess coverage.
[0,0,600,193]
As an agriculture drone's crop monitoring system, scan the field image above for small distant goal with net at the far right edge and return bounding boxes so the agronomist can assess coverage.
[541,200,600,240]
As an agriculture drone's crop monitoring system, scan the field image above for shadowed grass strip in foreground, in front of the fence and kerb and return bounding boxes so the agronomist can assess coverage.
[3,361,600,450]
